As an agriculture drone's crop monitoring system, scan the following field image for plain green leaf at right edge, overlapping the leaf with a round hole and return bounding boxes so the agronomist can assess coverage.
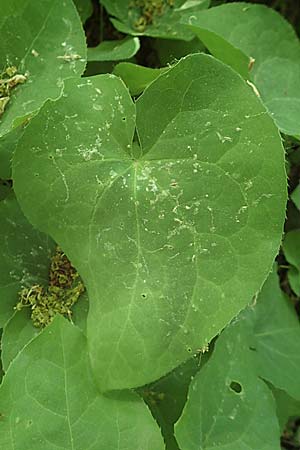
[253,272,300,400]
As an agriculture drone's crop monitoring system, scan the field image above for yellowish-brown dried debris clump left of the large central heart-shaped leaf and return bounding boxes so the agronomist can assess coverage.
[15,247,85,328]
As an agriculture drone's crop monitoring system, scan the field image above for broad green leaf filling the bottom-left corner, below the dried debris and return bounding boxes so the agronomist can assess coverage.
[0,316,164,450]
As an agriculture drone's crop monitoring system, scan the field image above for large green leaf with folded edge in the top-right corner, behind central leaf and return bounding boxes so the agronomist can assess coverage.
[182,3,300,135]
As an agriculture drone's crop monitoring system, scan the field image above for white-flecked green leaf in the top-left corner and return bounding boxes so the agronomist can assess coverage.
[0,0,86,136]
